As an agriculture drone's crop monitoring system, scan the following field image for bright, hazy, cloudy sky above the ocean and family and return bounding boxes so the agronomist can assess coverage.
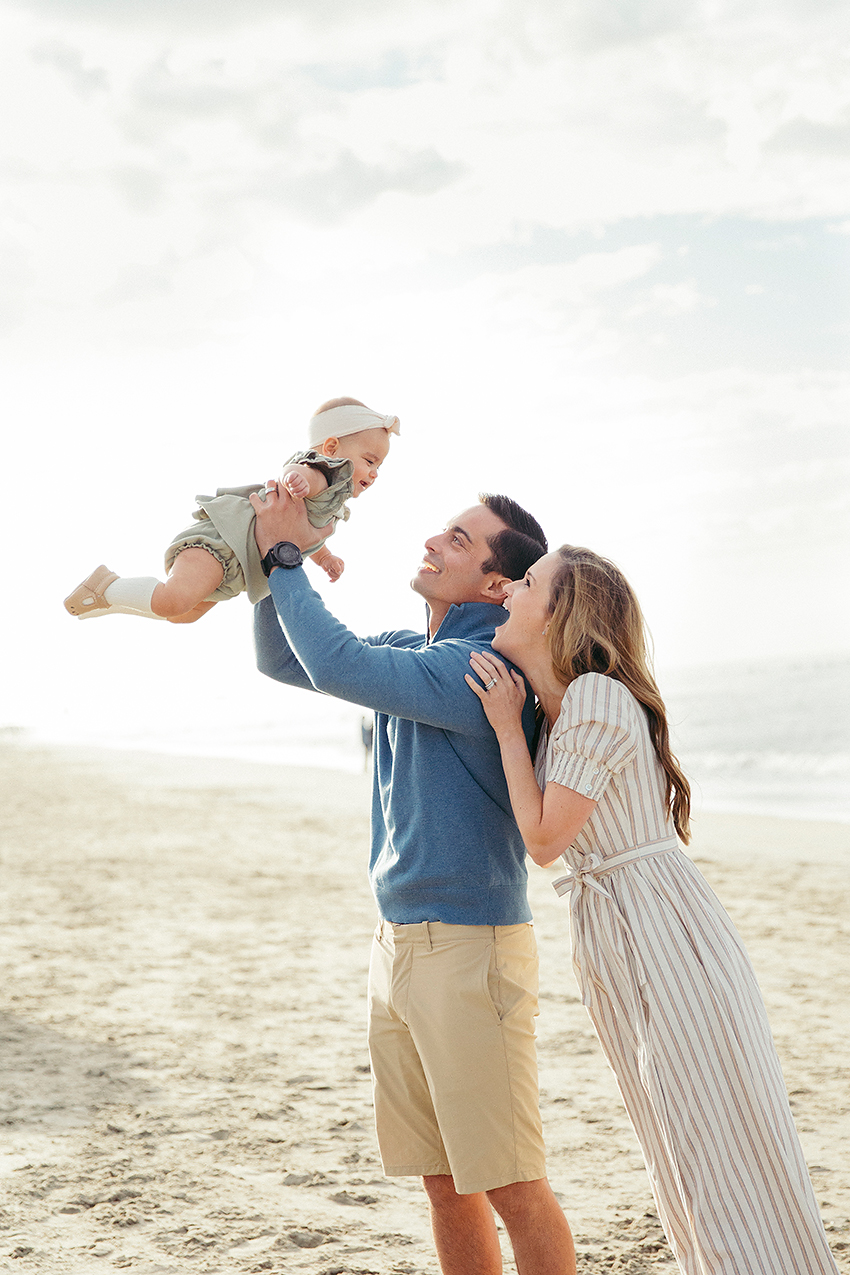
[0,0,850,749]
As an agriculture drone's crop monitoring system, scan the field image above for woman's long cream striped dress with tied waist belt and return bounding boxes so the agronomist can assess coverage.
[535,673,837,1275]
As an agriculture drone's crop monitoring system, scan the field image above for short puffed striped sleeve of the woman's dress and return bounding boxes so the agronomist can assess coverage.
[545,673,640,801]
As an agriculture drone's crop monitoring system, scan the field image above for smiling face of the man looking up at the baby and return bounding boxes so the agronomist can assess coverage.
[410,505,506,606]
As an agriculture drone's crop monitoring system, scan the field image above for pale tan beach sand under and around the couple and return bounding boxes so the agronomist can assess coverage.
[0,743,850,1275]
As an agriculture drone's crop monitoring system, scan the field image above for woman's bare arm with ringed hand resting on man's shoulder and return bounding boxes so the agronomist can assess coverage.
[465,653,596,867]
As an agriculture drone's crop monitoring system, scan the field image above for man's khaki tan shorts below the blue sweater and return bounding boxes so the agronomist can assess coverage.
[370,921,545,1195]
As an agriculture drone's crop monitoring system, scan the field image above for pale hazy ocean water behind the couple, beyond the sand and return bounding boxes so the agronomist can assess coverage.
[0,655,850,822]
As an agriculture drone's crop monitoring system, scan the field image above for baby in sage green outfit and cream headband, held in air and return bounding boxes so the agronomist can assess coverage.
[65,398,399,623]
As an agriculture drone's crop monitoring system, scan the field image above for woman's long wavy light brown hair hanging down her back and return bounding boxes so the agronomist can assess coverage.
[548,544,691,845]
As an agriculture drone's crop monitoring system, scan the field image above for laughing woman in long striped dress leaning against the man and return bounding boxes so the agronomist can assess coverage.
[466,546,837,1275]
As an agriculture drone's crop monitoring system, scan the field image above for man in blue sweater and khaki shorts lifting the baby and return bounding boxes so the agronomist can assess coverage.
[252,491,575,1275]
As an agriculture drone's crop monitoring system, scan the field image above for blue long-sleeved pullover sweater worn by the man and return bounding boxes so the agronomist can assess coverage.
[254,567,534,926]
